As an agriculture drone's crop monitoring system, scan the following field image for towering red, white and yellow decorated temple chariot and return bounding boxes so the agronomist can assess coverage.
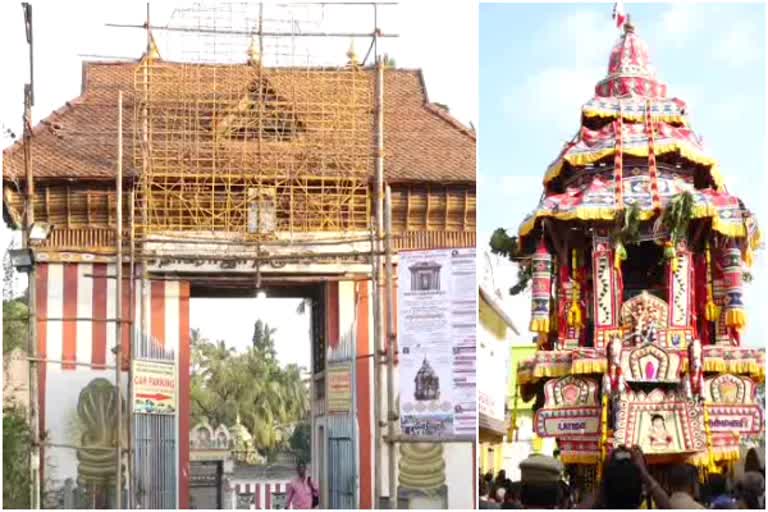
[517,23,765,496]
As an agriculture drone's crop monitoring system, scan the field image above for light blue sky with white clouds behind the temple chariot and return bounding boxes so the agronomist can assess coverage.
[478,2,768,346]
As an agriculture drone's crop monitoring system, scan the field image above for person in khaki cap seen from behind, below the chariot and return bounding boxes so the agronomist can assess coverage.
[520,454,563,509]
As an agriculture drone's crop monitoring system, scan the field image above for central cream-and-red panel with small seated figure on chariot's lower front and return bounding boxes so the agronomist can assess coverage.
[614,389,706,455]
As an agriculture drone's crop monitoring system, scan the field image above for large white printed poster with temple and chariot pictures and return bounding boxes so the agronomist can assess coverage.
[397,248,477,437]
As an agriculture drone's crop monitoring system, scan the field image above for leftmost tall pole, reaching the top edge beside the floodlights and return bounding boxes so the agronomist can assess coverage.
[21,2,43,509]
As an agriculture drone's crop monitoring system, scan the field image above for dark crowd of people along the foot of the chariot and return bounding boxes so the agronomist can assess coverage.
[478,446,765,510]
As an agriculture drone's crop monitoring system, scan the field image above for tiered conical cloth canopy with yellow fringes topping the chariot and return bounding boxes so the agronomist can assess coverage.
[519,25,760,255]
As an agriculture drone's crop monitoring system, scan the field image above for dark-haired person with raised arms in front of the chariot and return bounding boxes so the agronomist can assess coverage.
[577,446,671,509]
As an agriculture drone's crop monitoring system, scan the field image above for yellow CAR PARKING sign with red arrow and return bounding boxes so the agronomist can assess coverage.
[132,359,176,414]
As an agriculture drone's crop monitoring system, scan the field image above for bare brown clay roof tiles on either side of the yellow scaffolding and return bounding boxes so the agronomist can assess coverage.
[3,62,475,183]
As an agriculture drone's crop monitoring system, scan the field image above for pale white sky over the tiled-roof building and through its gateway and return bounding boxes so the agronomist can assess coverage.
[0,0,478,367]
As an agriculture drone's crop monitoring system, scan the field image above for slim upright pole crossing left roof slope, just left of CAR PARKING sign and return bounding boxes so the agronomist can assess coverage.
[115,91,123,509]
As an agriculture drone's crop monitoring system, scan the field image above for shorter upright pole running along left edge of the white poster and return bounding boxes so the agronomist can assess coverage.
[384,185,398,508]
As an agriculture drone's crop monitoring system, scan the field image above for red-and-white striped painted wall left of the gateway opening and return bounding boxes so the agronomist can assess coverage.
[36,263,189,507]
